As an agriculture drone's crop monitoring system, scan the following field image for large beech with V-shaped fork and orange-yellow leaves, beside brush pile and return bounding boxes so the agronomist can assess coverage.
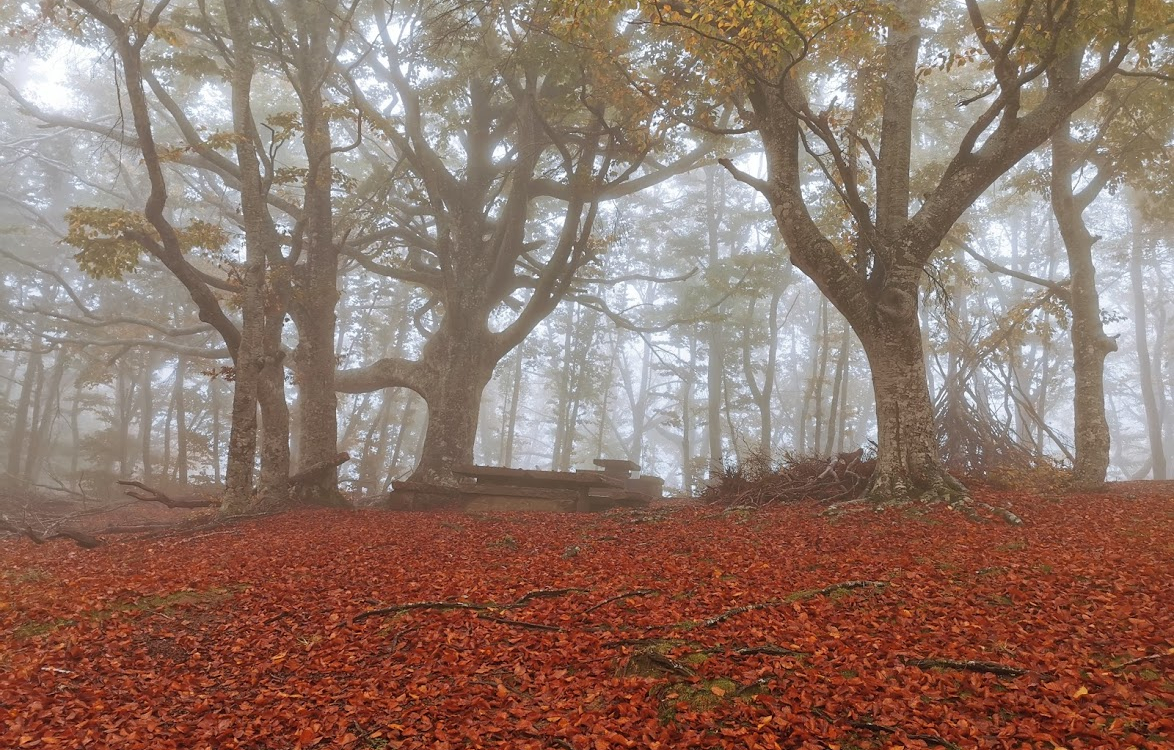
[615,0,1161,499]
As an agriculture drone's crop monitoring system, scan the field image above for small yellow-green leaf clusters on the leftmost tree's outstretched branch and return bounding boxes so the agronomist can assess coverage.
[65,207,229,279]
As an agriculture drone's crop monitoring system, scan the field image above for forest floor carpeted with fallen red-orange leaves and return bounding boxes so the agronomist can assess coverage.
[0,484,1174,750]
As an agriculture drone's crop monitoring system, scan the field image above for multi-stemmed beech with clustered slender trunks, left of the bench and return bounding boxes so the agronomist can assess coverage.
[5,0,356,512]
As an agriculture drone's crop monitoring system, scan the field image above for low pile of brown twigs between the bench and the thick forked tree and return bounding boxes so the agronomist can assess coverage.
[701,448,876,508]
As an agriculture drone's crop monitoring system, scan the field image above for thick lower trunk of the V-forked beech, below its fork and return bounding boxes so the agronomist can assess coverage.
[857,311,965,501]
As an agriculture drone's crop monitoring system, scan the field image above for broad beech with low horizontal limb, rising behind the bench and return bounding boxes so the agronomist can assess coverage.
[336,1,706,482]
